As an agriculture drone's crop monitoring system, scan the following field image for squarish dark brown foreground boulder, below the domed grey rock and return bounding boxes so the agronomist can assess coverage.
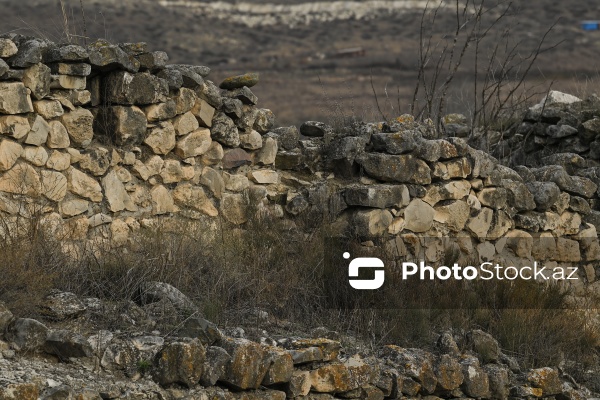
[153,340,206,388]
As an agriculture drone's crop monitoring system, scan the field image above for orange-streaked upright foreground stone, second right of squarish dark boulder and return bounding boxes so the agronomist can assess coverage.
[220,338,271,390]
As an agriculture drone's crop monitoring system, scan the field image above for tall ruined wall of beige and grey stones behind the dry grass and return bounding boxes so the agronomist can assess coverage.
[0,35,600,296]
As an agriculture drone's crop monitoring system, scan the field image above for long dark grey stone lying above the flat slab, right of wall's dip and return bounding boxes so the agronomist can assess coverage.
[356,153,431,185]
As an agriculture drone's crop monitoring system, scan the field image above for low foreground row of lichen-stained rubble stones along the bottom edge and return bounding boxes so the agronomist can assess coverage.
[0,288,593,400]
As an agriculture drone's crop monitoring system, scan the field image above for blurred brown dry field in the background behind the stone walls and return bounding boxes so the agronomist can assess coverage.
[0,0,600,125]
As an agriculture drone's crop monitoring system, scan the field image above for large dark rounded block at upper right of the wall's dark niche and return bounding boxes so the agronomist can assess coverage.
[104,71,169,105]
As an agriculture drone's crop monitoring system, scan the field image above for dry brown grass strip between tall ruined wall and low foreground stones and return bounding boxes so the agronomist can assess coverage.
[0,209,600,373]
